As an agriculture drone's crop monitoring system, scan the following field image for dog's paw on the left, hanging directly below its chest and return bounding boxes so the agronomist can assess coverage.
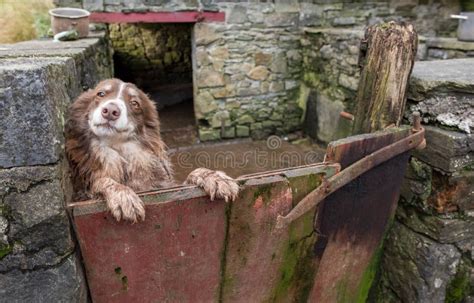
[105,185,145,223]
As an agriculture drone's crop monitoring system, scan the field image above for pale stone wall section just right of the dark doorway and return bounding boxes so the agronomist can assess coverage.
[194,4,303,140]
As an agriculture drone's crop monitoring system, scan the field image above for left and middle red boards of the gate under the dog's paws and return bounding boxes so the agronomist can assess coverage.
[70,164,338,303]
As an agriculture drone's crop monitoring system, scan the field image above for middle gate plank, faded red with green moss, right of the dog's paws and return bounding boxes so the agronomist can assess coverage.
[222,173,324,302]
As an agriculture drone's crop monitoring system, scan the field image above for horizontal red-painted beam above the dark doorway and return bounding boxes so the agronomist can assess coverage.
[89,11,225,23]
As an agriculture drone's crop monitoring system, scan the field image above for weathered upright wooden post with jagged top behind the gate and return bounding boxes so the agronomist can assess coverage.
[352,21,418,134]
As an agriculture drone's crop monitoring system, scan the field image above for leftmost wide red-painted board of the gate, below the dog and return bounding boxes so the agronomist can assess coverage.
[74,198,226,303]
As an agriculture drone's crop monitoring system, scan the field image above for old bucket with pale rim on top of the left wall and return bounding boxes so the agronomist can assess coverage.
[49,7,90,38]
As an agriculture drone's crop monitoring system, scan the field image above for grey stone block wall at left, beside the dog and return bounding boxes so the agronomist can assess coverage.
[0,38,112,302]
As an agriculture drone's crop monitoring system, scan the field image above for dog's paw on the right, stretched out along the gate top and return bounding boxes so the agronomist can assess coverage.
[186,168,239,202]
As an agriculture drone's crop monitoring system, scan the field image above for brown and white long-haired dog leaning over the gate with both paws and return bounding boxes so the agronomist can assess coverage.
[66,79,239,222]
